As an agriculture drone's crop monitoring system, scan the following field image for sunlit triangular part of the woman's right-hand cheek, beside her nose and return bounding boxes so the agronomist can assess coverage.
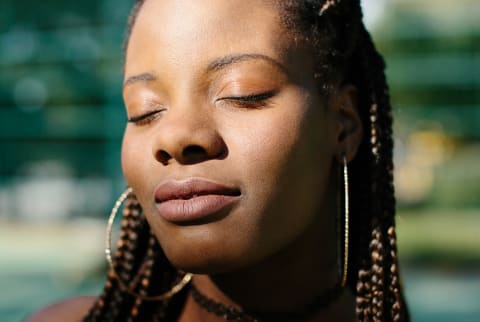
[223,108,302,209]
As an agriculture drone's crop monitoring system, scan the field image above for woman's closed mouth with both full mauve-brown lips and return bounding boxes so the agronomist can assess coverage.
[154,178,241,223]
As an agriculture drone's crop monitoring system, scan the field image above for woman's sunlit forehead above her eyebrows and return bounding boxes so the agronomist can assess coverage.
[125,0,288,74]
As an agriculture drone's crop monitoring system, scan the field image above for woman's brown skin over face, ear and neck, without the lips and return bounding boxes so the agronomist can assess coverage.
[27,0,362,322]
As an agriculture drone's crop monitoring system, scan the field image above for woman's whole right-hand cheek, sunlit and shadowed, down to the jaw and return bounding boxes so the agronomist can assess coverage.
[222,98,332,244]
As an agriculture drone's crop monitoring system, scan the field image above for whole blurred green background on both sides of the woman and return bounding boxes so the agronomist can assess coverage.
[0,0,480,322]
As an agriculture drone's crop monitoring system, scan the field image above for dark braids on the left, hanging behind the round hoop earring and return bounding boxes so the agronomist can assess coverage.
[84,194,185,322]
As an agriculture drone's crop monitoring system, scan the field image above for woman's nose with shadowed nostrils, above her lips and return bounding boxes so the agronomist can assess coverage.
[152,110,227,165]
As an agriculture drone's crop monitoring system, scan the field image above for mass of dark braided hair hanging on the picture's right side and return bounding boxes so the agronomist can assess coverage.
[300,0,408,321]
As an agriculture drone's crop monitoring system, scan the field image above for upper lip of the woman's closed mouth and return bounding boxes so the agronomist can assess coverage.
[154,178,241,203]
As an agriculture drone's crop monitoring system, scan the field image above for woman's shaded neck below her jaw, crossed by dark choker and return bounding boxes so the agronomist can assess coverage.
[179,205,355,322]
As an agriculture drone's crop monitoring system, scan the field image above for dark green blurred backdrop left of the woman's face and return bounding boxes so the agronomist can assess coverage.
[0,0,131,219]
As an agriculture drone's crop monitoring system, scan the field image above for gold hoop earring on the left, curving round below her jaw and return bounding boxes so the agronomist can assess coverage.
[105,188,193,301]
